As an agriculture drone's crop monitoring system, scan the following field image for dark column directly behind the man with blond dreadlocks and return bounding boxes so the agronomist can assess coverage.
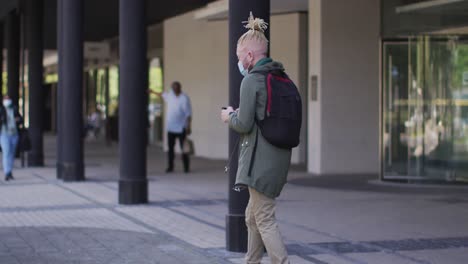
[226,0,270,252]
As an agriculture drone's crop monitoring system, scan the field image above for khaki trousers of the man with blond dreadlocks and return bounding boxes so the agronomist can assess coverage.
[245,188,289,264]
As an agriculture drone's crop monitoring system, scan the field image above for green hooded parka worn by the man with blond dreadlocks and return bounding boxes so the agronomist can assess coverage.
[229,58,291,198]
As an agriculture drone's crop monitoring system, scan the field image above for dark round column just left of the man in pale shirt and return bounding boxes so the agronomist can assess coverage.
[119,0,148,204]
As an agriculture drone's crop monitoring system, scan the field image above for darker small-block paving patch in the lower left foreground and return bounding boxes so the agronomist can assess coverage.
[0,227,227,264]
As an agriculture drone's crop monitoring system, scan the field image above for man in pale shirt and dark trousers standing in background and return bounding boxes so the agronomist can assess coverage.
[150,81,192,173]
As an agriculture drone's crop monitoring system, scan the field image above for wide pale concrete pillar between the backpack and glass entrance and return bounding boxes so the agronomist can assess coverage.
[307,0,380,175]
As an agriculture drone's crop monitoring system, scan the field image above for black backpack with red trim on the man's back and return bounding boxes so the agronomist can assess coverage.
[257,71,302,149]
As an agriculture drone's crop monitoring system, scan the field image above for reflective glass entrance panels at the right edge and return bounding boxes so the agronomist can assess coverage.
[382,36,468,181]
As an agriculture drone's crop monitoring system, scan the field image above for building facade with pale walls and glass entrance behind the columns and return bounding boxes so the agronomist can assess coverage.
[0,0,468,186]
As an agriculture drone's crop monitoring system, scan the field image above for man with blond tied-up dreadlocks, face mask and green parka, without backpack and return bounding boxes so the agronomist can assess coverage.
[221,13,291,264]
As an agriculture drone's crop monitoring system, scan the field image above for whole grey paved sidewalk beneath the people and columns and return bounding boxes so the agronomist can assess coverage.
[0,137,468,264]
